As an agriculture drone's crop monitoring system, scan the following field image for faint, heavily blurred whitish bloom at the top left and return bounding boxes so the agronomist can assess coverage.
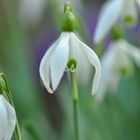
[18,0,47,26]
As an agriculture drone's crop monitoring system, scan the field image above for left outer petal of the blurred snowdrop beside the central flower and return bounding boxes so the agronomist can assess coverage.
[95,48,116,101]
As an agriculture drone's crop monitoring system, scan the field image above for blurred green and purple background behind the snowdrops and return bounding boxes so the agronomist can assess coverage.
[0,0,140,140]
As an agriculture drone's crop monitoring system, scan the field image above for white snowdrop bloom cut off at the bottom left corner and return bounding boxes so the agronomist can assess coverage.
[0,95,16,140]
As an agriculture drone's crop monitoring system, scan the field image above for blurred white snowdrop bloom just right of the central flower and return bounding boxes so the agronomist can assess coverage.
[96,39,140,101]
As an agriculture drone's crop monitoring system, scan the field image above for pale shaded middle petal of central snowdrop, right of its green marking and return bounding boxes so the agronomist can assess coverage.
[69,33,91,85]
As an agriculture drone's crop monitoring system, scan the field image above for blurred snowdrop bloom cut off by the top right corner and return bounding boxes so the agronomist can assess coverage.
[94,0,140,43]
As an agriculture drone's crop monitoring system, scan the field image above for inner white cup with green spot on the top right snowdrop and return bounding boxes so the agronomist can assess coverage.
[122,0,138,25]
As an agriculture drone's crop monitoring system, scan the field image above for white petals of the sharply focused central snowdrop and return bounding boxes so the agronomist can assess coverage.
[40,32,101,94]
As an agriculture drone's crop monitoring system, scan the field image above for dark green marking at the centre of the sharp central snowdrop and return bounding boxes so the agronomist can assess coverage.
[66,59,77,72]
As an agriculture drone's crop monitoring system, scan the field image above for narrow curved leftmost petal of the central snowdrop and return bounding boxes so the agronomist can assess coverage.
[39,38,60,93]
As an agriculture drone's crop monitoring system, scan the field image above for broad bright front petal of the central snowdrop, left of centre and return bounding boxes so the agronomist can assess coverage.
[50,32,69,90]
